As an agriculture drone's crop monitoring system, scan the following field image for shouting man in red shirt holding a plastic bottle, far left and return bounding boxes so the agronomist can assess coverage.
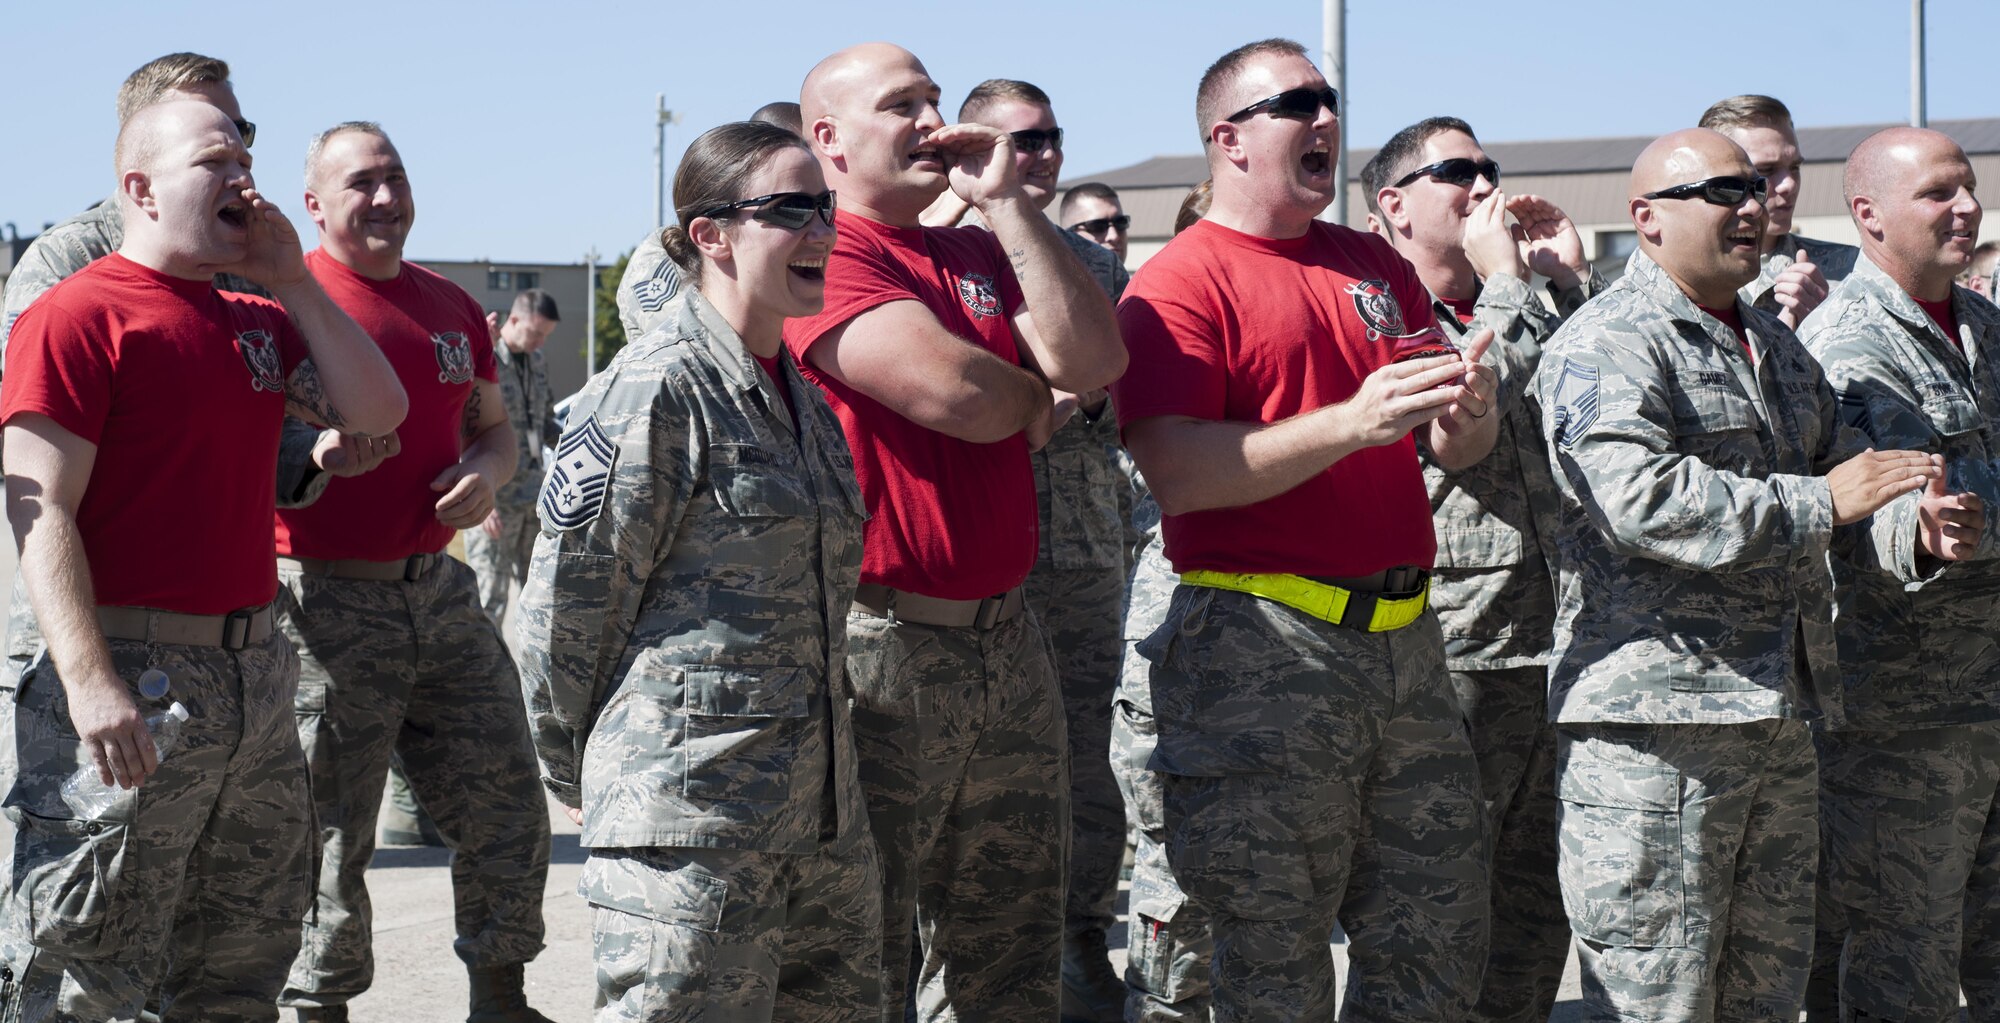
[0,100,406,1021]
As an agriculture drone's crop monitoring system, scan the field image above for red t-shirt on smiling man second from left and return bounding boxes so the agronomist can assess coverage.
[278,250,500,561]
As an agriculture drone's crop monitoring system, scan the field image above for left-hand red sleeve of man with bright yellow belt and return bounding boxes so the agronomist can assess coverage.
[1112,282,1228,430]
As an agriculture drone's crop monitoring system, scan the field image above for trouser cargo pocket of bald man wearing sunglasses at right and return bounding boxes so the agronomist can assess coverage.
[1556,757,1688,949]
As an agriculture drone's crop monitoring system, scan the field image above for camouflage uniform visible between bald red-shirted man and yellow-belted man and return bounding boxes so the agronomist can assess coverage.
[1026,223,1132,1019]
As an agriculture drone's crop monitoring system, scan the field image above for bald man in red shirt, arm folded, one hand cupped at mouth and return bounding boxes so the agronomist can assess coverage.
[784,44,1124,1021]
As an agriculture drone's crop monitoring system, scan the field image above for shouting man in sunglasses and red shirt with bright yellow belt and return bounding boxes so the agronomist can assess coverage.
[1114,40,1500,1021]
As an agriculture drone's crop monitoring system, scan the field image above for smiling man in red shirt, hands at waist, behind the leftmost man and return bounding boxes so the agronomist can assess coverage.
[278,122,548,1023]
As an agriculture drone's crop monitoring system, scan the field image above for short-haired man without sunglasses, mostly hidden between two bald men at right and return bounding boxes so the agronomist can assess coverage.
[1700,94,1860,330]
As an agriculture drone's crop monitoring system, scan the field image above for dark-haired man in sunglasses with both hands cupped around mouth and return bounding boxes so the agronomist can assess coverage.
[1360,118,1604,1023]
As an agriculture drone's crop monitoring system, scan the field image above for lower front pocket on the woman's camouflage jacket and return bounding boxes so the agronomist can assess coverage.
[680,665,810,803]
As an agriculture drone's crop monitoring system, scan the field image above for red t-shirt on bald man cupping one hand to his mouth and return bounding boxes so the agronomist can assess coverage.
[784,212,1040,599]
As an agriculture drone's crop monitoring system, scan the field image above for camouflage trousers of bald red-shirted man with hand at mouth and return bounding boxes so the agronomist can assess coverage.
[848,609,1070,1023]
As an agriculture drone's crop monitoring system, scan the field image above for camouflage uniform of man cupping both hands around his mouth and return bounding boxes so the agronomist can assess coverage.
[1416,272,1604,1023]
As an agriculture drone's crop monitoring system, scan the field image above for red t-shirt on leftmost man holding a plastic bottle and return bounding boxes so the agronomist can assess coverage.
[0,252,306,615]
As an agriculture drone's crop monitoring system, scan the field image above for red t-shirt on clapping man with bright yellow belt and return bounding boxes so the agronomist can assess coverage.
[1112,220,1438,575]
